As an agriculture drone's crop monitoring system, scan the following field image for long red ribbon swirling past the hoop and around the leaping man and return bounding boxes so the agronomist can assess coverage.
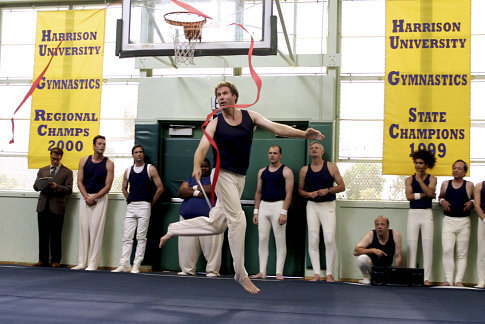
[171,0,263,205]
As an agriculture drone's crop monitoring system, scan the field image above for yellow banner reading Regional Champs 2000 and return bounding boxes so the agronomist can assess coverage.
[28,9,106,170]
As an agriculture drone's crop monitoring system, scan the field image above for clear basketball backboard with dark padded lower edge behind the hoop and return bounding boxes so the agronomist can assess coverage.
[117,0,277,57]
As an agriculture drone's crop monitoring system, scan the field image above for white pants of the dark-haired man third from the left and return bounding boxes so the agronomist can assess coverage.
[120,201,152,267]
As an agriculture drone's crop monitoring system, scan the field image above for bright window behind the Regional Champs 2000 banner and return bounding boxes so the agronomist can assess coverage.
[0,2,139,192]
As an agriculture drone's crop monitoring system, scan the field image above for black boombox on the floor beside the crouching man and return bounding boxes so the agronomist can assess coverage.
[371,267,424,287]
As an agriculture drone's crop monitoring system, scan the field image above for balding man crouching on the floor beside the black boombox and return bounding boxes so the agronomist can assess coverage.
[354,216,402,284]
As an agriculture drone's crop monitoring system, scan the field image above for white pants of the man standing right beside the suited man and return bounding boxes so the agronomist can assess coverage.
[78,195,108,268]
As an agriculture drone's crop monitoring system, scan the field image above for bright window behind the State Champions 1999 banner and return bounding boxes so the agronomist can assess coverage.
[338,0,485,200]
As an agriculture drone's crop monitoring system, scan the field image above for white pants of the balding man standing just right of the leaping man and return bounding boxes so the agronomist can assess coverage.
[258,200,286,275]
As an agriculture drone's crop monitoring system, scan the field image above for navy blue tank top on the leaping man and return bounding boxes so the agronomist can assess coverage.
[212,110,254,175]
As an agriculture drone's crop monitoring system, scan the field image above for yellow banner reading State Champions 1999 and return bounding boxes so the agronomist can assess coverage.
[382,0,471,175]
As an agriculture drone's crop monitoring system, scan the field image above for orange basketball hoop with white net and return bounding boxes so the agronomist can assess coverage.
[163,11,206,64]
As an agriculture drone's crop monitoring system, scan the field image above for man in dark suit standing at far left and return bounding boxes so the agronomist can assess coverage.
[34,147,72,268]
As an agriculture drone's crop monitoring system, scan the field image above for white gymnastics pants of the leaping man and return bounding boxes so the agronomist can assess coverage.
[167,169,248,283]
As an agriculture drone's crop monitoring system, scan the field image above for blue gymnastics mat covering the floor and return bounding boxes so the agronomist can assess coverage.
[0,265,485,324]
